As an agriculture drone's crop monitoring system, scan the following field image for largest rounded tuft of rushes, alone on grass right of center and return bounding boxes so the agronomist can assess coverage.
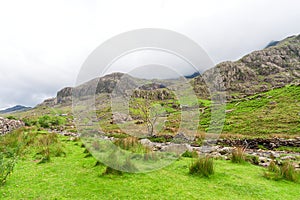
[189,156,214,177]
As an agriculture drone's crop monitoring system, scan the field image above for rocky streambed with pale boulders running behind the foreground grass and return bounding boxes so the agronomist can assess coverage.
[56,132,300,170]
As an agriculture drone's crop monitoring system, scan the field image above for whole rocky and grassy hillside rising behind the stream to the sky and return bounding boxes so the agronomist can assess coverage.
[5,36,300,137]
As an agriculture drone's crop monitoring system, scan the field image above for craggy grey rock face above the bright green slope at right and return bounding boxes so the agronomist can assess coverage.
[192,35,300,98]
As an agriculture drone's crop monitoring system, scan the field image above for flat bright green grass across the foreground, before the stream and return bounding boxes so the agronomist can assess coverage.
[0,137,300,200]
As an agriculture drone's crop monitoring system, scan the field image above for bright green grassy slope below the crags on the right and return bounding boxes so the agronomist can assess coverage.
[200,86,300,137]
